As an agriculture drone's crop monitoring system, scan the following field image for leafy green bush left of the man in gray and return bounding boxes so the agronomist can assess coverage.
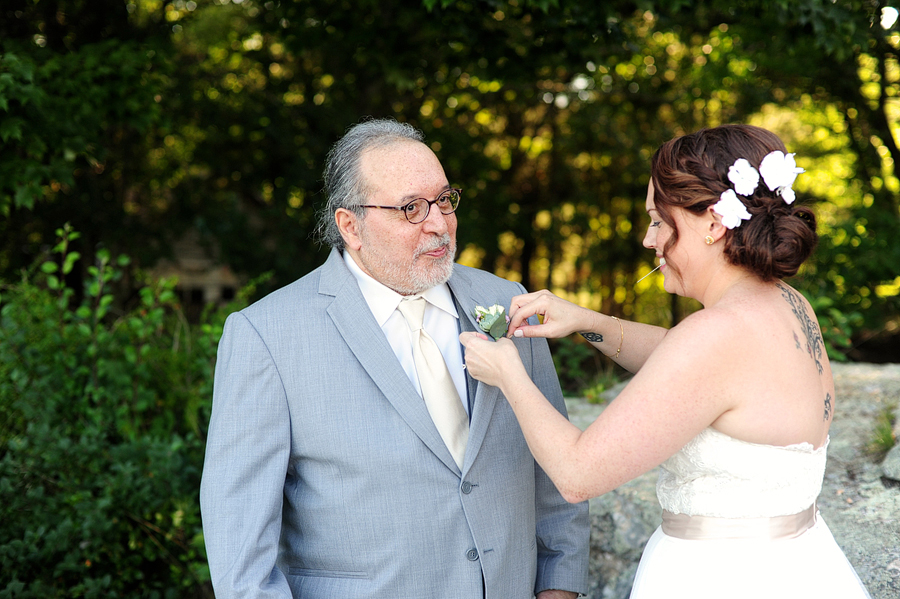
[0,227,222,598]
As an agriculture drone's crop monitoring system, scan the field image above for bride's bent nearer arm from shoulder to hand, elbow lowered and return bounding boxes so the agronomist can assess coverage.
[460,312,733,502]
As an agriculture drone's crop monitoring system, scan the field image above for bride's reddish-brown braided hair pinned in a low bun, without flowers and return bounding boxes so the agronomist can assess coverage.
[650,125,818,281]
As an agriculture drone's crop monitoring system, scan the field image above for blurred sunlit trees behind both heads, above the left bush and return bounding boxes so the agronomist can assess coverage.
[0,0,900,358]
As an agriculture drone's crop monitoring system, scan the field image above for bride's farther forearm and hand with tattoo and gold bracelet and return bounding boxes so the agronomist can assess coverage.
[509,290,668,372]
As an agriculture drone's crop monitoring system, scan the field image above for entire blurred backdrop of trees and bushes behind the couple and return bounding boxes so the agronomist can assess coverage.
[0,0,900,597]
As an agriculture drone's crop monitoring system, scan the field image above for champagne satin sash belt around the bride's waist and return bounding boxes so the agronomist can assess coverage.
[662,503,818,541]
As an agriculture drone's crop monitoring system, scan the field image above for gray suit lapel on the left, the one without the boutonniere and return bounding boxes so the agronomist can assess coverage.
[319,250,459,471]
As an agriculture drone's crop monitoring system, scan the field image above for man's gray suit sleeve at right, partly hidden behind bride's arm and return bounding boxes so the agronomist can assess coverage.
[522,288,590,594]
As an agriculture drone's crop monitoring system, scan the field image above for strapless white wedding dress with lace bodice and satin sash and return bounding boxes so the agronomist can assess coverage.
[631,428,871,599]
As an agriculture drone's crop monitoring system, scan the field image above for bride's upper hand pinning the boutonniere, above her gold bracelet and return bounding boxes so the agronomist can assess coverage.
[507,289,597,339]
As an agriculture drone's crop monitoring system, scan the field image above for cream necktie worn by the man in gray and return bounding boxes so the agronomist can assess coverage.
[397,297,469,470]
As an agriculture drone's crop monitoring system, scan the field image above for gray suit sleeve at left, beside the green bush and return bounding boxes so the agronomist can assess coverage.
[200,313,291,599]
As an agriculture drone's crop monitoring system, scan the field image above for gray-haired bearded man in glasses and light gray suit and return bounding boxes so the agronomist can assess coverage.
[200,120,589,599]
